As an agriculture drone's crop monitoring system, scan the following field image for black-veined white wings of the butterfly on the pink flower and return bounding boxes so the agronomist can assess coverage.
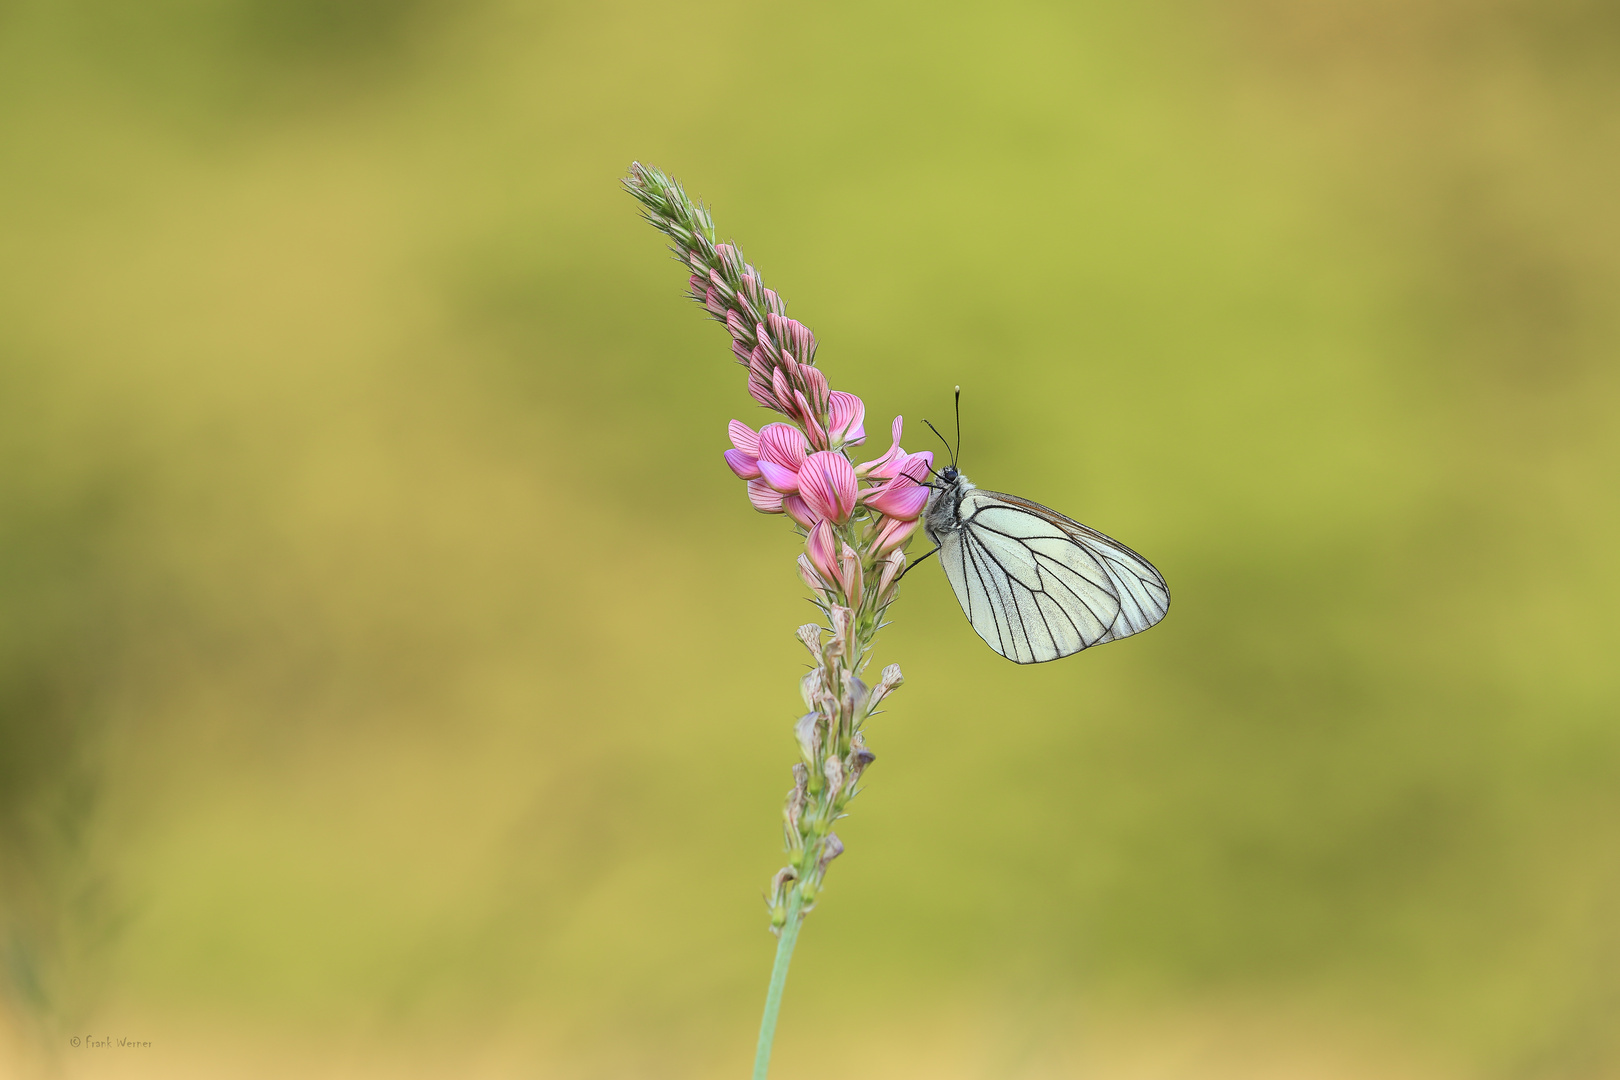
[940,487,1170,664]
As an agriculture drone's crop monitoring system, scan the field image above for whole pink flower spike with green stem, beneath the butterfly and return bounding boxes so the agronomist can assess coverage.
[624,164,913,1080]
